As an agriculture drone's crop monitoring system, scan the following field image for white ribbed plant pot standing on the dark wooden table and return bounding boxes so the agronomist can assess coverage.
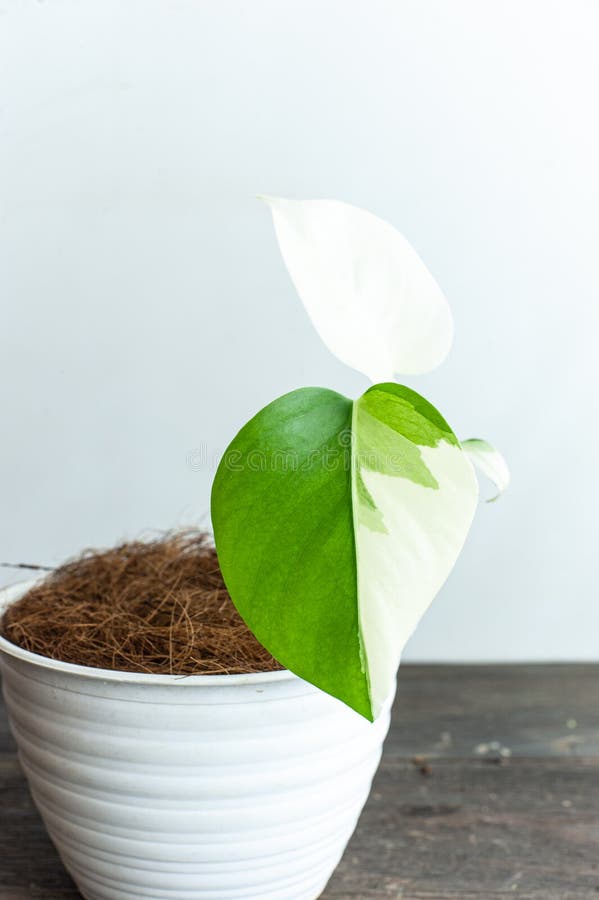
[0,585,391,900]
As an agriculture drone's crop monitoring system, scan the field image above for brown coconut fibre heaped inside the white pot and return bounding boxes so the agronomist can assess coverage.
[0,531,282,675]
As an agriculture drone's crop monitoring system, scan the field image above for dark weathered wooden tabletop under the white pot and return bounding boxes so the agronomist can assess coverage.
[0,665,599,900]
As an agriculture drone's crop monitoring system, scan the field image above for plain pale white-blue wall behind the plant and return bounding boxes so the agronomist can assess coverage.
[0,0,599,660]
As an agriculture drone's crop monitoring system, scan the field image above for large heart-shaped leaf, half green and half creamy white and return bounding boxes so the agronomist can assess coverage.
[212,384,478,719]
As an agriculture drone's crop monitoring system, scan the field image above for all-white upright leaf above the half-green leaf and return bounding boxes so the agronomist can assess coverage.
[263,197,453,382]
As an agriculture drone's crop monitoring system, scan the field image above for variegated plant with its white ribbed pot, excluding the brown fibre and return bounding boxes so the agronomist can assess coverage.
[0,198,508,900]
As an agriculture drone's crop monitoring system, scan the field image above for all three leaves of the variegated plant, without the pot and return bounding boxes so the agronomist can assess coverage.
[212,199,508,720]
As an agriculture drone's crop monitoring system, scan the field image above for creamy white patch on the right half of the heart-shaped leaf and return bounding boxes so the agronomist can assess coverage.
[355,437,478,717]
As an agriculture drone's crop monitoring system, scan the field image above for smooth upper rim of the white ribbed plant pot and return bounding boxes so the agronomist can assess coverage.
[0,576,297,687]
